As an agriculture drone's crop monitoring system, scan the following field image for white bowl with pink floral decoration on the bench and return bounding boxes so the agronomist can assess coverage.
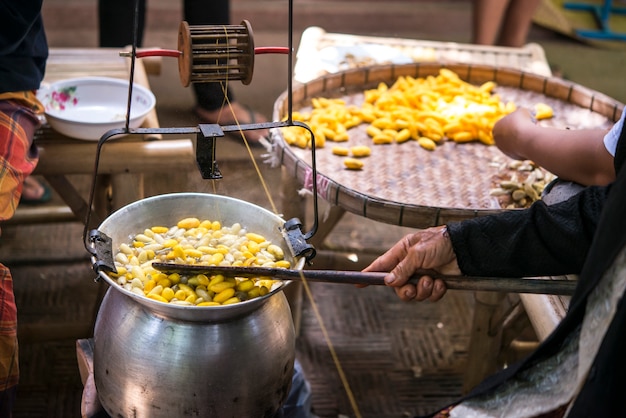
[37,77,156,141]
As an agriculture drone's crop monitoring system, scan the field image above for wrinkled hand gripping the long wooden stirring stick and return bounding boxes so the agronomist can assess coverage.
[363,226,461,302]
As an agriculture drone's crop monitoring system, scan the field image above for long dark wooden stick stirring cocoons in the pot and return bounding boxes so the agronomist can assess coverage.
[152,263,577,295]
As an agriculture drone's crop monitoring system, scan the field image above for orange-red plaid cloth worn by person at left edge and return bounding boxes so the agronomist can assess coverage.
[0,91,43,415]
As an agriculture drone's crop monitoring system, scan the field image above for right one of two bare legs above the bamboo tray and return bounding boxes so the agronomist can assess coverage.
[498,0,541,48]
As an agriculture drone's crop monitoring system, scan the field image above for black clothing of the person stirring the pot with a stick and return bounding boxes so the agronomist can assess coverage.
[432,113,626,418]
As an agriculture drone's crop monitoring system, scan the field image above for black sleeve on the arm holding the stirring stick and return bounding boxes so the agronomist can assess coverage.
[448,186,610,277]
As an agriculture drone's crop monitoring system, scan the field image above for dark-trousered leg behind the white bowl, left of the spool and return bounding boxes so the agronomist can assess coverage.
[98,0,146,48]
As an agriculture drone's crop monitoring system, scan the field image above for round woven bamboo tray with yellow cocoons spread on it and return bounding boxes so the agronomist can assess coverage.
[272,63,623,228]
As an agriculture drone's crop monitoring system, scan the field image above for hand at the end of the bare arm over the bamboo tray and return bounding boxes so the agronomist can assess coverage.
[493,108,537,160]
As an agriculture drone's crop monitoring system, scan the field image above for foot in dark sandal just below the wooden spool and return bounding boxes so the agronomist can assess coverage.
[195,102,269,143]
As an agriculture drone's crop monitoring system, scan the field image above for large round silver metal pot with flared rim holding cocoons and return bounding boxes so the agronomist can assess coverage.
[94,193,295,418]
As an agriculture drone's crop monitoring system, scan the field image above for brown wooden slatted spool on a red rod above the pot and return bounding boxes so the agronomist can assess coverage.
[178,20,254,87]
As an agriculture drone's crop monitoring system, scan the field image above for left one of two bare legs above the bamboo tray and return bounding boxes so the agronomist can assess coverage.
[472,0,509,45]
